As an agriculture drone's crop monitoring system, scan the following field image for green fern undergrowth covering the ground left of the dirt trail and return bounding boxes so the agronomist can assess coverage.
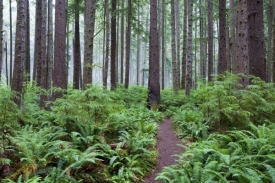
[0,83,163,183]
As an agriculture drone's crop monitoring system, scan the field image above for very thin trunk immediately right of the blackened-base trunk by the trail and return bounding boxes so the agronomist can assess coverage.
[161,0,166,89]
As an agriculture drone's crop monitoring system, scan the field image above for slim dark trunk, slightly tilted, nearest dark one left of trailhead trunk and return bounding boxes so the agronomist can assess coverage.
[124,0,132,89]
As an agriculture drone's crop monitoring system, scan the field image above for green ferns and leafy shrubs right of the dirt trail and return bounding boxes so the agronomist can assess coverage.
[157,73,275,183]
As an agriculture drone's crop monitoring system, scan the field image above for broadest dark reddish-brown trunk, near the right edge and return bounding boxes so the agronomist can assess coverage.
[247,0,266,81]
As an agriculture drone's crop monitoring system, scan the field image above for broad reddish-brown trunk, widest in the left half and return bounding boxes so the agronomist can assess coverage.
[53,0,67,100]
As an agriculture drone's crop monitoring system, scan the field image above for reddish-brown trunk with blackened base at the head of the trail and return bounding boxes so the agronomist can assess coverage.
[148,0,160,110]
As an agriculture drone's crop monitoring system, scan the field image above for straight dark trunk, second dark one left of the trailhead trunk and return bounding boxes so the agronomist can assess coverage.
[111,0,117,90]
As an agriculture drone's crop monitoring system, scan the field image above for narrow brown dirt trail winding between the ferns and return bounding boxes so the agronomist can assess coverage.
[144,119,183,183]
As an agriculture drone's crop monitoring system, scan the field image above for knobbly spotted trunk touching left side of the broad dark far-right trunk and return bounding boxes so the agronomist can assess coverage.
[236,0,248,87]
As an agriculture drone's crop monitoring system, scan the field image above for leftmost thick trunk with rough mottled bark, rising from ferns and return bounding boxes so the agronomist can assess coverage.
[11,0,27,106]
